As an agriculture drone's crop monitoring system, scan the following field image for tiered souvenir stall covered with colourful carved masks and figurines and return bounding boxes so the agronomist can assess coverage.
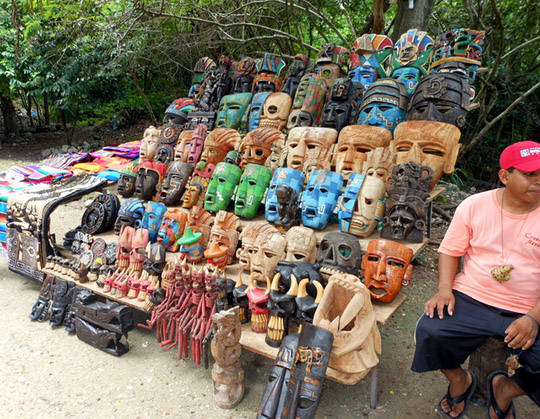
[7,29,484,418]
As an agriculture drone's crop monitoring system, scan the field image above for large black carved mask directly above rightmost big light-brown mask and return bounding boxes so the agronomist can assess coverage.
[407,73,471,128]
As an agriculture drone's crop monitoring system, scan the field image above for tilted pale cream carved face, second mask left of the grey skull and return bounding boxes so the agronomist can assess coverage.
[251,233,287,282]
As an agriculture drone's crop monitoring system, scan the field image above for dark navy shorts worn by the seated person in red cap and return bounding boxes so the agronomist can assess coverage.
[411,291,540,406]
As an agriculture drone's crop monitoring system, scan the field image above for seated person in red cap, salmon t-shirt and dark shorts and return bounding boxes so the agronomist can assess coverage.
[412,141,540,418]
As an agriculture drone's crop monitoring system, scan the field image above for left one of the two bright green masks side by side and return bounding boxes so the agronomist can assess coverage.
[204,162,242,212]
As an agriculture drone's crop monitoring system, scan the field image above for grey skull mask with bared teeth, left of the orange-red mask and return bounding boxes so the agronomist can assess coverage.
[317,231,362,277]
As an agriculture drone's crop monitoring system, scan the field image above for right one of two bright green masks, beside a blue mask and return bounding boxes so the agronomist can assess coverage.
[234,164,272,218]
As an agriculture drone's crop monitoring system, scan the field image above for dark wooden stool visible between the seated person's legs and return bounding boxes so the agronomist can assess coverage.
[469,338,509,405]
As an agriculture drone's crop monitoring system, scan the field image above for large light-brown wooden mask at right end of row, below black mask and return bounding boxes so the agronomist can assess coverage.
[392,121,461,189]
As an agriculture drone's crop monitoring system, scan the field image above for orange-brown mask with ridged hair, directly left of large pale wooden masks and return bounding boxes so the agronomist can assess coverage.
[240,128,284,170]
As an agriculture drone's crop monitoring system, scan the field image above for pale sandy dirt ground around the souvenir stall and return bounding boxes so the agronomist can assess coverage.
[0,126,539,419]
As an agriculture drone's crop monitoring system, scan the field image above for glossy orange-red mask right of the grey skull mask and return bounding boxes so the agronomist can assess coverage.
[362,240,413,303]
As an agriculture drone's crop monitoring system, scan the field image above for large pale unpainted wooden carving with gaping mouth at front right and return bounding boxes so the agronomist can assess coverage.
[313,274,381,374]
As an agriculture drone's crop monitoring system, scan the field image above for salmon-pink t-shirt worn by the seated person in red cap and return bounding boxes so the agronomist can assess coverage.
[439,190,540,313]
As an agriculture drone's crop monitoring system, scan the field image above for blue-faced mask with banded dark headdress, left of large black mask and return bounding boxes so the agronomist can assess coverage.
[358,79,409,133]
